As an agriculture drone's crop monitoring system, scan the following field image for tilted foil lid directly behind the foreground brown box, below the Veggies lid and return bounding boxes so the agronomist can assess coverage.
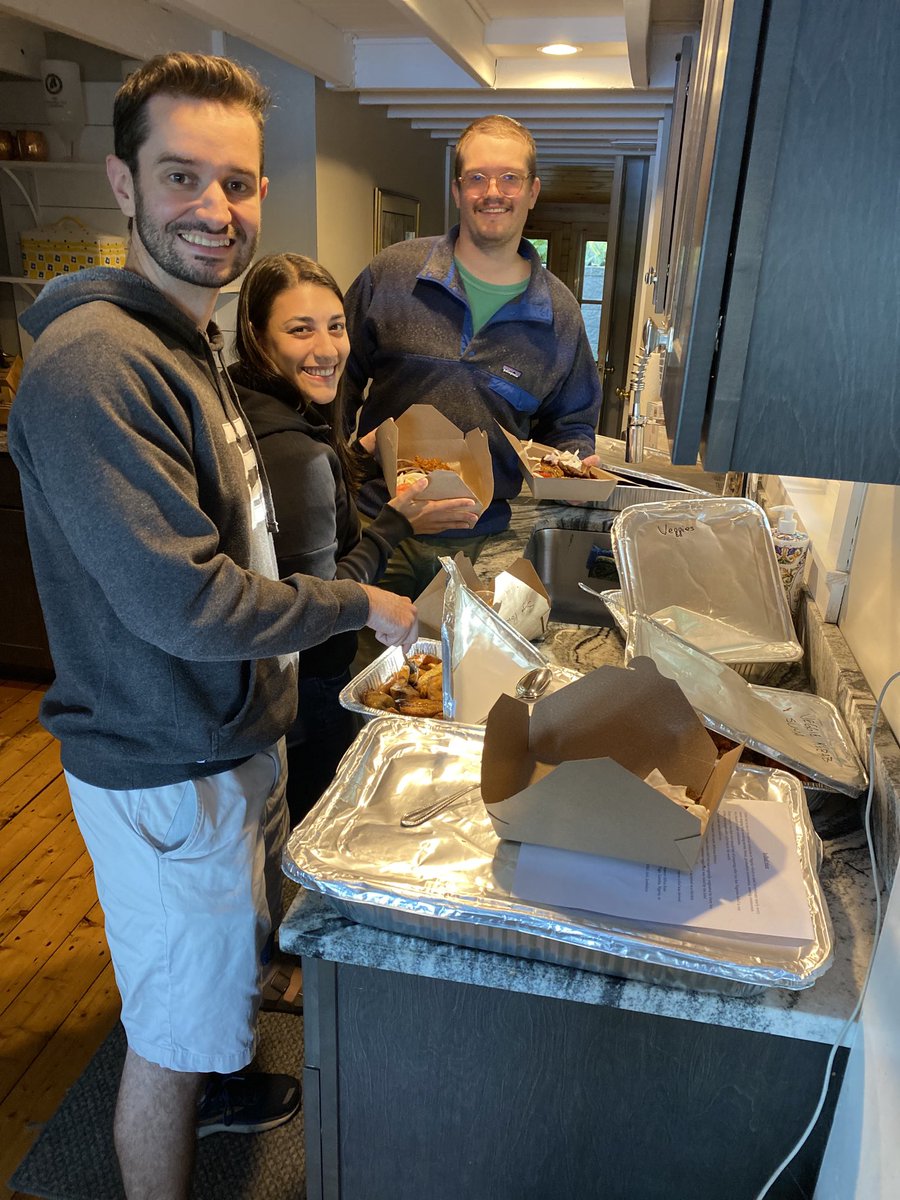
[625,613,869,796]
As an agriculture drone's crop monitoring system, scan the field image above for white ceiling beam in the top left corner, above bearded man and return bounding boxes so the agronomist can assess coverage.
[0,0,211,59]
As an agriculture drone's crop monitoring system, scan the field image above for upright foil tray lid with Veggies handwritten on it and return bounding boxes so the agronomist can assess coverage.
[611,497,803,673]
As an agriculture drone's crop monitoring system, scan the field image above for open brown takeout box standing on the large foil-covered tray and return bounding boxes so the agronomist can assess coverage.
[481,658,743,870]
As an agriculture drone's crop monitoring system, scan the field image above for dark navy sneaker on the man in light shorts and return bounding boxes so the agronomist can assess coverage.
[197,1072,300,1138]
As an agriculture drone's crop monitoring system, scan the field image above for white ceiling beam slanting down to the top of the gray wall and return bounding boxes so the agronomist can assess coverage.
[153,0,355,88]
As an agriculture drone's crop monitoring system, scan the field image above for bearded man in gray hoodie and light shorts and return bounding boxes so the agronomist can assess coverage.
[10,54,415,1200]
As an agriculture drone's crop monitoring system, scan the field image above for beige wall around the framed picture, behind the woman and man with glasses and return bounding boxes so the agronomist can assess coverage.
[316,82,444,288]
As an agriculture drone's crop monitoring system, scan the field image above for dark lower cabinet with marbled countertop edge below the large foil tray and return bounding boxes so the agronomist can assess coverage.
[289,892,864,1200]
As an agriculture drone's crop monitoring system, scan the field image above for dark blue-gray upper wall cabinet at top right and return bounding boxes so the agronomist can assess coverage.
[662,0,900,484]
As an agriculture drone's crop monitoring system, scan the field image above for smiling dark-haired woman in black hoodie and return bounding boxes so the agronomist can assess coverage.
[228,254,476,826]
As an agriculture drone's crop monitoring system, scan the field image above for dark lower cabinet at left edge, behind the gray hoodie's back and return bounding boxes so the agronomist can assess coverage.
[0,452,53,678]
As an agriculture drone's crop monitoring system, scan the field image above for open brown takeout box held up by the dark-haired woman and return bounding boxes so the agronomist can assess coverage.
[376,404,493,516]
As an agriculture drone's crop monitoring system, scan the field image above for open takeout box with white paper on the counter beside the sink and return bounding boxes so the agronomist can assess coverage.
[415,551,550,641]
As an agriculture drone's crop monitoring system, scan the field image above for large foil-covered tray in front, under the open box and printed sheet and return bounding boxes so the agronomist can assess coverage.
[284,718,833,996]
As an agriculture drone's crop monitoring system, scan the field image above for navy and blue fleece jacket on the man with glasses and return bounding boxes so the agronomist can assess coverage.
[344,227,601,536]
